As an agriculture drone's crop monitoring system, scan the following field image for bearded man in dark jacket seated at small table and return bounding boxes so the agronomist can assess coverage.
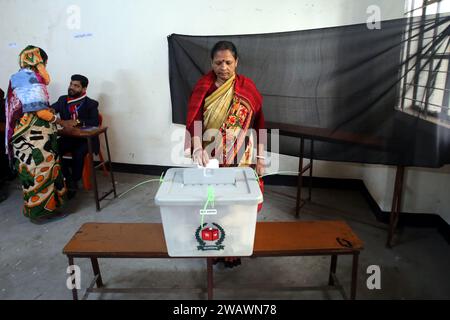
[52,74,100,197]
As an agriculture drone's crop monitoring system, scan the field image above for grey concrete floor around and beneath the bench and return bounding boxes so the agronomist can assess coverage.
[0,173,450,300]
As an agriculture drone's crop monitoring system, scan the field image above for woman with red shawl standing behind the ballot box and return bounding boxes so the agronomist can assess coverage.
[185,41,265,267]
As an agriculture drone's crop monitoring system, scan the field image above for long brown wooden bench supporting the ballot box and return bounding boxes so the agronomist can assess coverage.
[63,221,363,300]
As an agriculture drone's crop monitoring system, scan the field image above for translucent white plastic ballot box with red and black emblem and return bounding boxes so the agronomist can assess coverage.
[155,167,263,257]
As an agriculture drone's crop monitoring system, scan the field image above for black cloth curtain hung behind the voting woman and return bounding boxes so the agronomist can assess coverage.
[168,16,450,167]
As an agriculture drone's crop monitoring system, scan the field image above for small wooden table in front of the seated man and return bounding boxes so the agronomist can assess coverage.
[58,127,117,211]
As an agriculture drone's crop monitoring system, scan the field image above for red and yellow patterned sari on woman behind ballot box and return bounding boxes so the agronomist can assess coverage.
[185,71,264,211]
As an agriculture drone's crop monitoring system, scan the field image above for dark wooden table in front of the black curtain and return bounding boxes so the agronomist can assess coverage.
[266,121,405,248]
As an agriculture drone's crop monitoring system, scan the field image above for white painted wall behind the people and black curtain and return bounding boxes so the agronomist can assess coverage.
[0,0,449,222]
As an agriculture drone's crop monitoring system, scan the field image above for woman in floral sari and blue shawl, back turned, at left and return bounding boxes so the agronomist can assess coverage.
[5,46,71,222]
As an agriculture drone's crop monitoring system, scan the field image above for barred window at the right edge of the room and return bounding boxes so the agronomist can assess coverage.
[398,0,450,127]
